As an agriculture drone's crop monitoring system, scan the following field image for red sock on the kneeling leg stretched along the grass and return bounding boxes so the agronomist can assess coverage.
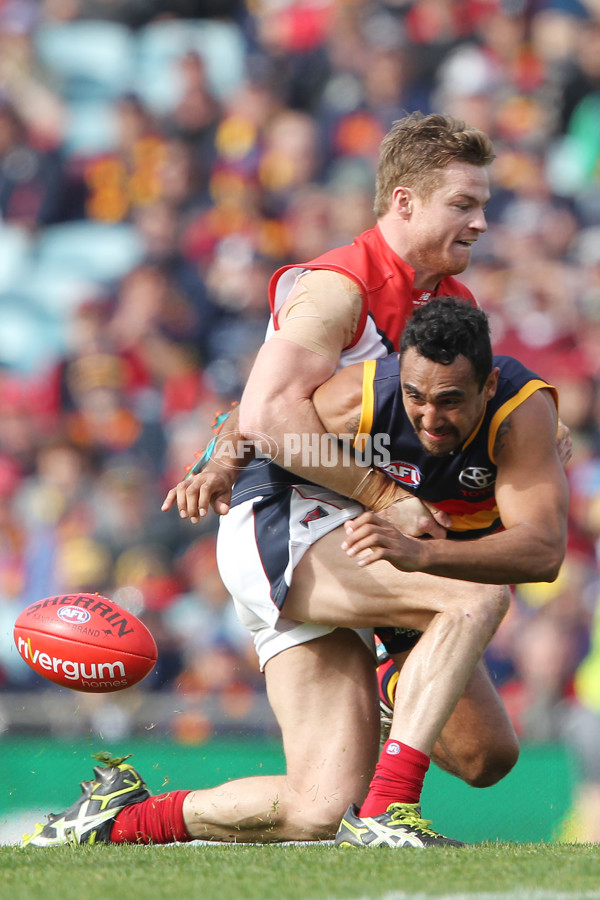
[110,791,193,844]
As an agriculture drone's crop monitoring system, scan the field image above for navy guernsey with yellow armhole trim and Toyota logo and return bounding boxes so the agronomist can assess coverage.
[355,353,558,540]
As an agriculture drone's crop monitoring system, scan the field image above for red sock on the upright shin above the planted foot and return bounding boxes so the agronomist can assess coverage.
[360,740,430,816]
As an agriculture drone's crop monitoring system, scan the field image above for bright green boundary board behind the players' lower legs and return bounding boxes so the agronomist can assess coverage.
[0,736,575,848]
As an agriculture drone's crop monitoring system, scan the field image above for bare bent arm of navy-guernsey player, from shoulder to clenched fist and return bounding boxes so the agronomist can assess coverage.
[342,391,568,584]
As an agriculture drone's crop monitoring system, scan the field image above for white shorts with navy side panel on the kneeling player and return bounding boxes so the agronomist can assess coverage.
[217,484,375,670]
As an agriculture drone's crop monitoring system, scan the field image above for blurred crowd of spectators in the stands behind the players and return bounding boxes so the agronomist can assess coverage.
[0,0,600,840]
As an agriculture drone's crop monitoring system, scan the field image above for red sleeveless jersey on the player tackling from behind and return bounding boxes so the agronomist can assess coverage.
[269,226,475,367]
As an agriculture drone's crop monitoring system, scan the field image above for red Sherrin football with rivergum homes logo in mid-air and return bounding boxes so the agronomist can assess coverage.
[14,594,157,694]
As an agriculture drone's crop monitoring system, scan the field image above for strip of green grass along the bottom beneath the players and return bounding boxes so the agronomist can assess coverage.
[0,844,600,900]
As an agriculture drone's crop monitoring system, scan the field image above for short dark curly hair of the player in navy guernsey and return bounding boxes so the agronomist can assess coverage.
[400,297,493,390]
